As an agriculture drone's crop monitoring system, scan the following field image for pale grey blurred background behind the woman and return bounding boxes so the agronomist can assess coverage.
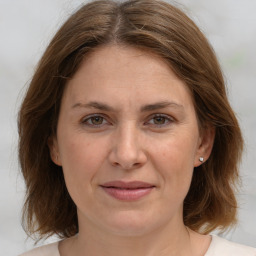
[0,0,256,256]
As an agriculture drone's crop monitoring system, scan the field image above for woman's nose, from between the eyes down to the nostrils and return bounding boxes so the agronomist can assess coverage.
[109,125,147,170]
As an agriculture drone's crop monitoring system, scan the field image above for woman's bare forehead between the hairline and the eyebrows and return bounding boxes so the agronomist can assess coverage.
[64,45,193,111]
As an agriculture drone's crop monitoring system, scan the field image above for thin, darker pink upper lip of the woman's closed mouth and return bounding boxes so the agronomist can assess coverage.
[101,180,155,189]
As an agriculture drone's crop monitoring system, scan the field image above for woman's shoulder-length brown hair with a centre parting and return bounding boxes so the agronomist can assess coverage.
[18,0,243,238]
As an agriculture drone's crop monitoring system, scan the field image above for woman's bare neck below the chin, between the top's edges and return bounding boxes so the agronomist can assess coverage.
[60,214,198,256]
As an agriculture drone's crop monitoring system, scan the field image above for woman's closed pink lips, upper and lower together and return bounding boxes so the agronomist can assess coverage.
[100,181,155,201]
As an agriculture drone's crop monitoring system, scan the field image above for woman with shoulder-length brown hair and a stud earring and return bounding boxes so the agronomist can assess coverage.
[19,0,256,256]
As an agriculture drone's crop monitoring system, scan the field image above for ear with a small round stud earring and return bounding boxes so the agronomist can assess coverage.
[194,126,215,167]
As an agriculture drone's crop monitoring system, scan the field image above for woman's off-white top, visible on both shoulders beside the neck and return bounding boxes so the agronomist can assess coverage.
[20,235,256,256]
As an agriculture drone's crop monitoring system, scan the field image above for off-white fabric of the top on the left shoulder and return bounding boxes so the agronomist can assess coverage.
[19,242,60,256]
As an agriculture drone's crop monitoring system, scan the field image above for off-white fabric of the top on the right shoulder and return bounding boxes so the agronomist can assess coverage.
[205,236,256,256]
